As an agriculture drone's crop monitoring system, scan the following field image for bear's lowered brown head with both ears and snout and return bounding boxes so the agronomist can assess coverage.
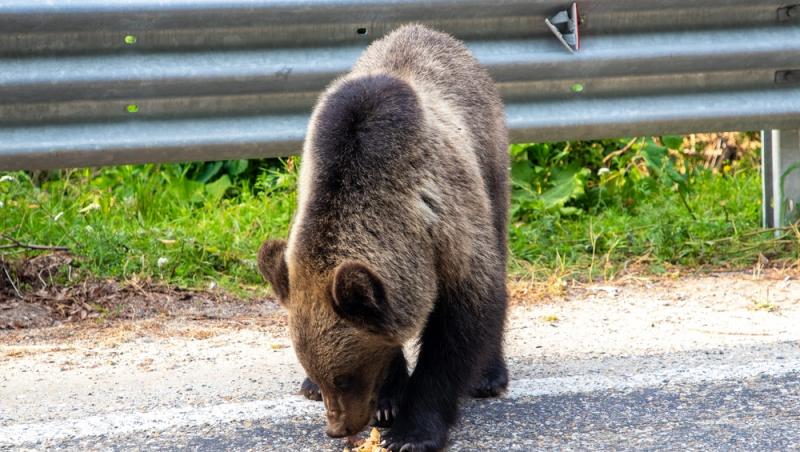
[258,240,402,437]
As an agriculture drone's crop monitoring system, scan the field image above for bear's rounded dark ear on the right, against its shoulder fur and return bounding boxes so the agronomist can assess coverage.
[331,261,393,335]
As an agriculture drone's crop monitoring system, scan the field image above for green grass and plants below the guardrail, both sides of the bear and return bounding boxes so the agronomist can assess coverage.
[0,134,800,297]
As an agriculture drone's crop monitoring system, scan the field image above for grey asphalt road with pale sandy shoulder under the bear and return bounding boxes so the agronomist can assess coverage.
[0,281,800,451]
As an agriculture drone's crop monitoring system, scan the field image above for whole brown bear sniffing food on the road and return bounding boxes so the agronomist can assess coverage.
[259,25,509,451]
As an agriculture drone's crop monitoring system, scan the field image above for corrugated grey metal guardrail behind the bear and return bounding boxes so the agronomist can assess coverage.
[0,0,800,223]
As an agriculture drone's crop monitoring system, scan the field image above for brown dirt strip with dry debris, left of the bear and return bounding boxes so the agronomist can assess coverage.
[0,253,278,329]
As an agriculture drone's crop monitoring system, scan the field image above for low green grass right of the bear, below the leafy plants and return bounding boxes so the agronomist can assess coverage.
[510,168,800,280]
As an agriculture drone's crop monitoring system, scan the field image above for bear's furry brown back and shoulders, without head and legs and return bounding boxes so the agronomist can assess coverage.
[288,25,508,304]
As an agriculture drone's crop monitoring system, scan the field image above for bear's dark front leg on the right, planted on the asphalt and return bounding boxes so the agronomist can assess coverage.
[386,281,506,451]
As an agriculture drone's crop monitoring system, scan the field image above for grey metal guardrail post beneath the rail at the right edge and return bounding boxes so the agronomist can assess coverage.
[761,129,800,228]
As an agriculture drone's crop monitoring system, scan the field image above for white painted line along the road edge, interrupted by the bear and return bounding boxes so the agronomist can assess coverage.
[0,357,800,446]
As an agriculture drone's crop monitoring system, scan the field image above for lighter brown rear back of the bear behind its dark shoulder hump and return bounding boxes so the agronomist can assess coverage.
[353,25,510,261]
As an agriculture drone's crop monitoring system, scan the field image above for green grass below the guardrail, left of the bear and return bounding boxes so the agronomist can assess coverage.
[0,165,295,293]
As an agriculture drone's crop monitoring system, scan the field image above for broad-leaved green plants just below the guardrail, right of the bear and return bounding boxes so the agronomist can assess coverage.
[511,136,694,220]
